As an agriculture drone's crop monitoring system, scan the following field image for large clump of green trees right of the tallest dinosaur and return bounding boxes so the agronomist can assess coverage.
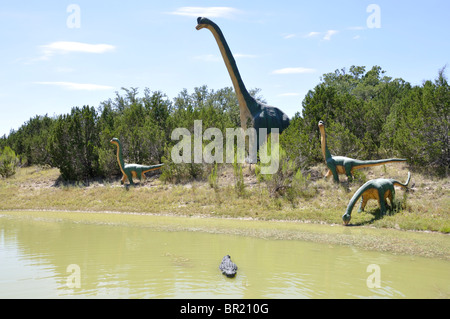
[280,66,450,176]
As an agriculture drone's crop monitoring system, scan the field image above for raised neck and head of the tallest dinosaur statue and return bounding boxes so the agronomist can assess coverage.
[198,18,260,122]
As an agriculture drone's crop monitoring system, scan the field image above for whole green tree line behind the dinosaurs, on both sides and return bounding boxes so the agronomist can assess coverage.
[0,66,450,181]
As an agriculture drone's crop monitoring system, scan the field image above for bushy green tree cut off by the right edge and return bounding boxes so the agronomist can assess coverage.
[385,69,450,176]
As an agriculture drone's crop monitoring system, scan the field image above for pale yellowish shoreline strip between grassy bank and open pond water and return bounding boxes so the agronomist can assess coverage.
[0,209,450,260]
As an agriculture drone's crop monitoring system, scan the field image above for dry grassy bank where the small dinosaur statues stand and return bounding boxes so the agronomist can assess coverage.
[0,164,450,233]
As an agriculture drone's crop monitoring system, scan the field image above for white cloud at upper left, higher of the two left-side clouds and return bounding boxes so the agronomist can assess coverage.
[40,41,115,60]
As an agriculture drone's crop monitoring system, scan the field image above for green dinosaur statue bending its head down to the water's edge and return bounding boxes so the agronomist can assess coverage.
[342,172,411,225]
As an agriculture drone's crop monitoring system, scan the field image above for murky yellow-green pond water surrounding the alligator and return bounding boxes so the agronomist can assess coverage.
[0,214,450,298]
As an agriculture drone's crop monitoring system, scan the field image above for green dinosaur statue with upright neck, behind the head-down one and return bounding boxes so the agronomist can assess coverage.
[319,121,406,183]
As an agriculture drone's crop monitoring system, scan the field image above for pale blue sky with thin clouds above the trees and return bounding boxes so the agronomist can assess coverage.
[0,0,450,136]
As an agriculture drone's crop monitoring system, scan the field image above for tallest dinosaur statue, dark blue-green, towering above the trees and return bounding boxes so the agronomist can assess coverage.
[196,17,289,151]
